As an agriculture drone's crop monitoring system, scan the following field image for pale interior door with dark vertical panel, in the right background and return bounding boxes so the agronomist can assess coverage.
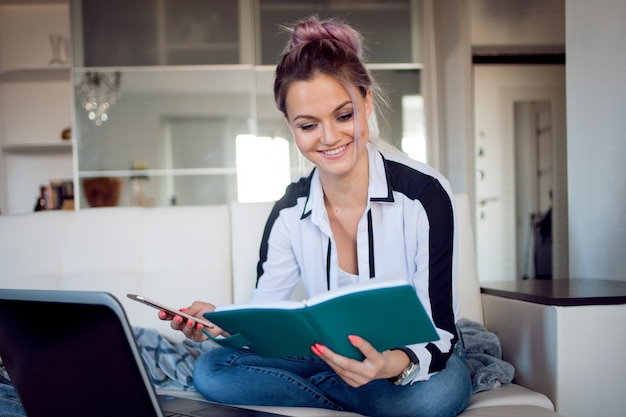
[473,65,568,282]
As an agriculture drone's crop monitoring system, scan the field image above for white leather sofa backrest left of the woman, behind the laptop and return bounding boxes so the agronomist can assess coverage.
[0,205,232,339]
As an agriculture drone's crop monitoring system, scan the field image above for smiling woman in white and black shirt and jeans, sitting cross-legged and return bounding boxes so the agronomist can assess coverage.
[161,18,471,417]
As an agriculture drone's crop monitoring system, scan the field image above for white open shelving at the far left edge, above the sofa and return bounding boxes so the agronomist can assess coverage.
[0,1,73,214]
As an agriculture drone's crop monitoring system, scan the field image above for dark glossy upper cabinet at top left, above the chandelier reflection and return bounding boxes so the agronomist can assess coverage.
[72,0,244,67]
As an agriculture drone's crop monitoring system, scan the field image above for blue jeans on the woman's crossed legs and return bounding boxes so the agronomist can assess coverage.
[193,348,472,417]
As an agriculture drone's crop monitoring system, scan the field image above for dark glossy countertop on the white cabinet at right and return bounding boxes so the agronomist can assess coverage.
[480,279,626,306]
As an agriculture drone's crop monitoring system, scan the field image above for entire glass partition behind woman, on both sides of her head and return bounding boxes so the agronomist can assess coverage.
[73,66,425,208]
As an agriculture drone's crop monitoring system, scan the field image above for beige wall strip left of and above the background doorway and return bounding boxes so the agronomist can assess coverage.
[430,0,565,197]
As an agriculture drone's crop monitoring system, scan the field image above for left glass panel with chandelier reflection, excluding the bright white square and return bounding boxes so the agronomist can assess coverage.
[74,66,255,207]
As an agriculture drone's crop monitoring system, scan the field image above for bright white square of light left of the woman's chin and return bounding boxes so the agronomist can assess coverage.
[235,135,291,203]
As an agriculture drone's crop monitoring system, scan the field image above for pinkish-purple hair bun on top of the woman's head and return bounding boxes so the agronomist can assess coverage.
[289,16,362,58]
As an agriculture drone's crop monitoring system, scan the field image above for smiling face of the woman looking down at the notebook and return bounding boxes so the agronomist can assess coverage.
[285,75,372,176]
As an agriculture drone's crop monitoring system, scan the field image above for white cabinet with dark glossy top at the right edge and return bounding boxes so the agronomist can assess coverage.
[482,279,626,417]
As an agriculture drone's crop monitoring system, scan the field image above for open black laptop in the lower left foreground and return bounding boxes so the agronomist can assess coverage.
[0,289,288,417]
